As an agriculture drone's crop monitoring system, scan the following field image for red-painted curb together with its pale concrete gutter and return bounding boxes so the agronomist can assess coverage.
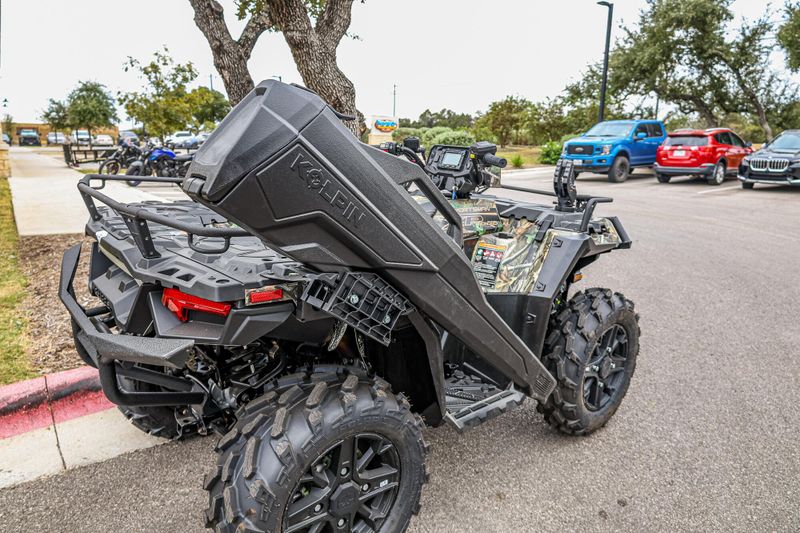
[0,367,167,488]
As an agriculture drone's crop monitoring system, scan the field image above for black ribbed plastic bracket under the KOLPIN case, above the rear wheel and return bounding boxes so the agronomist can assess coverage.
[303,272,414,346]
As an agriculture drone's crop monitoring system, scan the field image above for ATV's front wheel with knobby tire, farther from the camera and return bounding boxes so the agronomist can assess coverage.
[538,289,640,435]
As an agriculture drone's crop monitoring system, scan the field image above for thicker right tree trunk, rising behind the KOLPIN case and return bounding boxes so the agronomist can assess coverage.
[267,0,363,137]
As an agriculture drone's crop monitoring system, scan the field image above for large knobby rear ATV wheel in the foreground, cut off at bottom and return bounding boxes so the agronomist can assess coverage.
[204,367,427,533]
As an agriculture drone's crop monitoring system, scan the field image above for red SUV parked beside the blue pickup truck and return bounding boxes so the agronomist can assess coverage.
[654,128,753,185]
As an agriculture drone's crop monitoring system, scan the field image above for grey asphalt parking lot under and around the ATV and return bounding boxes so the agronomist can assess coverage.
[0,170,800,533]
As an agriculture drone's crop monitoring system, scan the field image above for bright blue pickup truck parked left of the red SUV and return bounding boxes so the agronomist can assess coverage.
[561,120,667,183]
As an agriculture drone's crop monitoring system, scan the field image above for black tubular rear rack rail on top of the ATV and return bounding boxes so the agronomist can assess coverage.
[78,174,252,259]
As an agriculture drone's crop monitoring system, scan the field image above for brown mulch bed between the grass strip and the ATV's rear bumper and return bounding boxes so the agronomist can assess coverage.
[19,234,99,374]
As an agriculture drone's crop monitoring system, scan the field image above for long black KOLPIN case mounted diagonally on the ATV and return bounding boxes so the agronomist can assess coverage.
[183,80,554,399]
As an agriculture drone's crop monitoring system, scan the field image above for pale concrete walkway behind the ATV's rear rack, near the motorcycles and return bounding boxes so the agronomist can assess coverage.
[8,146,163,236]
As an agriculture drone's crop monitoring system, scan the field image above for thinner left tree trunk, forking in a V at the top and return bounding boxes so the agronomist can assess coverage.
[189,0,271,105]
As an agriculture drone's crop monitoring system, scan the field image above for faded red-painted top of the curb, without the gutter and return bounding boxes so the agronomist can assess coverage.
[0,366,100,416]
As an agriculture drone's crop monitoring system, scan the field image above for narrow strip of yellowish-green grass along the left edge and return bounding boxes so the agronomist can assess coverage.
[0,178,36,385]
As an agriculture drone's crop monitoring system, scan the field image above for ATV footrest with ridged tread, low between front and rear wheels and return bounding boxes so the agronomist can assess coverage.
[444,374,525,432]
